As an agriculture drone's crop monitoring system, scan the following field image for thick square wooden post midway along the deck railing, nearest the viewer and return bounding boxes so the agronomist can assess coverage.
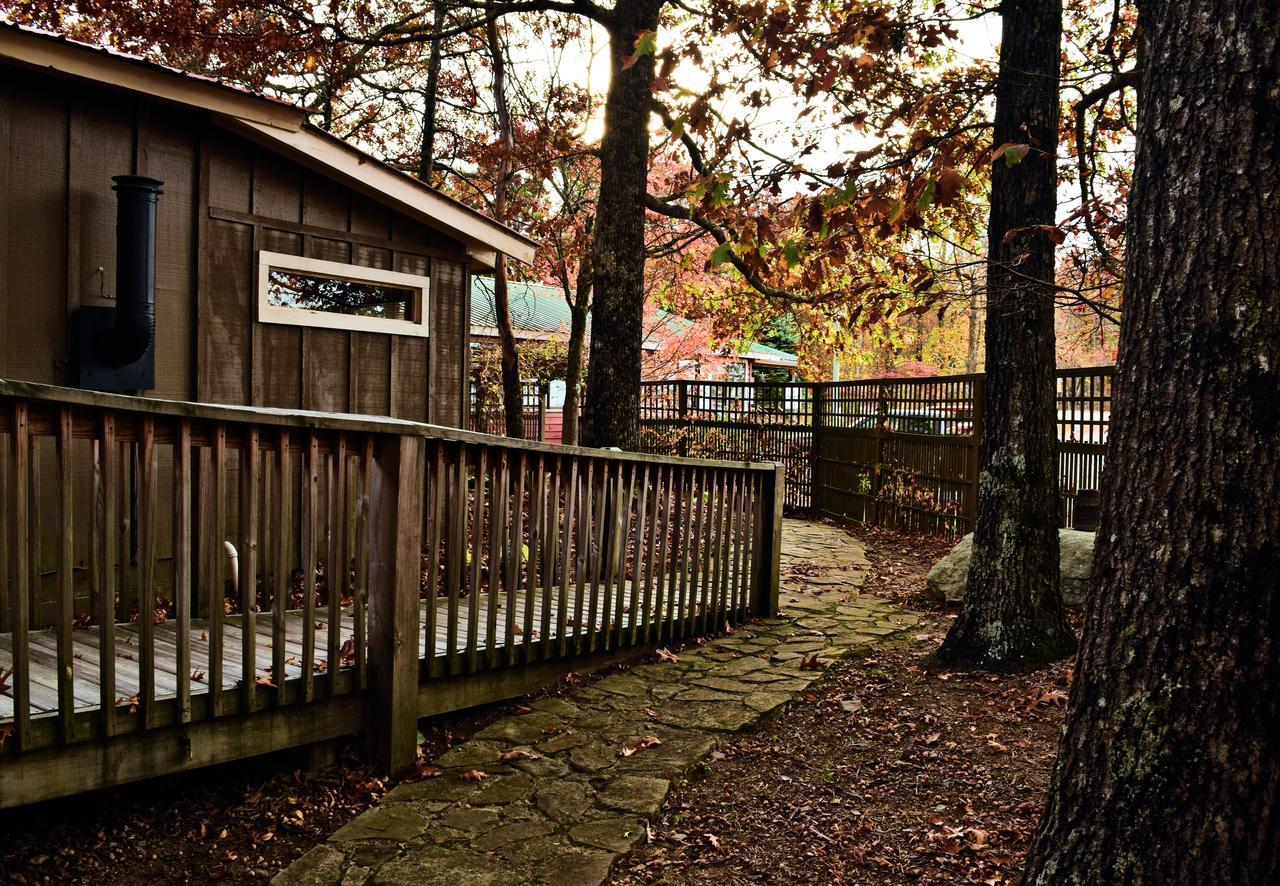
[367,435,425,773]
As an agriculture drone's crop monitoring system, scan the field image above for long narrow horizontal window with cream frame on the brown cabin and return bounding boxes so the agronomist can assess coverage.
[257,252,430,335]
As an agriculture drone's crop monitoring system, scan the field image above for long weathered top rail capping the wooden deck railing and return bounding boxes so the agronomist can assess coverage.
[0,379,773,471]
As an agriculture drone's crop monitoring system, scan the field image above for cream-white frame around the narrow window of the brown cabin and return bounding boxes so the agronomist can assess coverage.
[257,250,431,338]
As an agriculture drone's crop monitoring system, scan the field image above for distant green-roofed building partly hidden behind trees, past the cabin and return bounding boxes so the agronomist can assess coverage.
[471,277,797,382]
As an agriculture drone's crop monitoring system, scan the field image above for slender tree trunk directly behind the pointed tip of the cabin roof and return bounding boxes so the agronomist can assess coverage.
[485,10,525,439]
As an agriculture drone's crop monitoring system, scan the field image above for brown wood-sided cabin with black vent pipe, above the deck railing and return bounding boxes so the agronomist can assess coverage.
[0,26,535,426]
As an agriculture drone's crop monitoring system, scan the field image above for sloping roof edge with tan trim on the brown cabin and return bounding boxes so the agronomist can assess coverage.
[0,23,538,268]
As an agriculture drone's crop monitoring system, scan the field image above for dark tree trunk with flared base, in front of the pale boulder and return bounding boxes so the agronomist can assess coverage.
[937,0,1075,671]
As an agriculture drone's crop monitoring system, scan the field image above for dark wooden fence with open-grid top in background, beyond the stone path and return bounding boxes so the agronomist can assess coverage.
[640,366,1112,538]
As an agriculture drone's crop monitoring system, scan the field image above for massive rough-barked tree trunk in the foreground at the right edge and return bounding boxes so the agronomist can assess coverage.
[1027,0,1280,885]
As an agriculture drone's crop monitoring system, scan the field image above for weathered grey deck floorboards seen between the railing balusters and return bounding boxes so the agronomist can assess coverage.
[0,589,677,723]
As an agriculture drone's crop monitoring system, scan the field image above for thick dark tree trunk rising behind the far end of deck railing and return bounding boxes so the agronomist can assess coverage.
[581,0,664,449]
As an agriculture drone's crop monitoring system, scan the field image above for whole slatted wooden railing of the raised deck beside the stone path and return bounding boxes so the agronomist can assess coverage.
[0,382,783,808]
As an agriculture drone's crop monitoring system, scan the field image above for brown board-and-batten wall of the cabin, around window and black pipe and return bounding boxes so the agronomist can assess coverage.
[0,65,470,426]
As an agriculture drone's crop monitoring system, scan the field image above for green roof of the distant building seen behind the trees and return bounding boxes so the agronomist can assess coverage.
[471,277,797,366]
